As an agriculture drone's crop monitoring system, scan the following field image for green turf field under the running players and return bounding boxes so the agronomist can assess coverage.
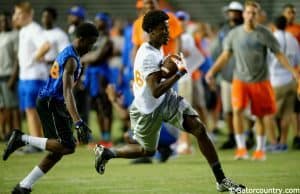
[0,144,300,194]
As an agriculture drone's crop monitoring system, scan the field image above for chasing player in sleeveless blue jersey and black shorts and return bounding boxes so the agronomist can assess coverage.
[3,23,99,193]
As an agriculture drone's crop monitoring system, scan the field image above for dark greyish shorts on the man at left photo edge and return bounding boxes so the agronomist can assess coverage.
[0,80,19,108]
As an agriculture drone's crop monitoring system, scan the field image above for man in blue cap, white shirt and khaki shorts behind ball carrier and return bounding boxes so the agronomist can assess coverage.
[175,11,207,154]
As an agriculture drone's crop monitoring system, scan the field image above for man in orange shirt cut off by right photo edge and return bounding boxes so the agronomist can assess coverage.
[282,4,300,44]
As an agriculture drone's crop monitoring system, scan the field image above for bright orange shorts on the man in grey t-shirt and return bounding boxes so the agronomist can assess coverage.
[231,79,276,117]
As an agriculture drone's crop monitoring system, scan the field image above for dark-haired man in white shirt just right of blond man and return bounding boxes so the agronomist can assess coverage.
[42,7,70,65]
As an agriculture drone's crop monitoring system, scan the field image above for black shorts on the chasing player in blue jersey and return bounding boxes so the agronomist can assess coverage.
[37,98,76,149]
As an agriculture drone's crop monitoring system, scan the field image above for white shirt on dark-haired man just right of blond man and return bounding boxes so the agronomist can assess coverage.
[44,27,70,61]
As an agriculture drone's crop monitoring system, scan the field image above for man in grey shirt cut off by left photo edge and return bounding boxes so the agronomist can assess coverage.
[0,12,20,139]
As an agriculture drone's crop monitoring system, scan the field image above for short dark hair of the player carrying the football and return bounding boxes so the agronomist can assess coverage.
[142,10,169,33]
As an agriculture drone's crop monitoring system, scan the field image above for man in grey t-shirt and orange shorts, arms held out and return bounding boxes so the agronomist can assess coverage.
[206,1,299,160]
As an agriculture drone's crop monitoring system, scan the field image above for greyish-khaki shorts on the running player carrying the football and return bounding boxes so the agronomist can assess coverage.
[130,90,198,151]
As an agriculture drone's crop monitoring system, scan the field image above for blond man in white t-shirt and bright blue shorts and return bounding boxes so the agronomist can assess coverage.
[13,2,50,141]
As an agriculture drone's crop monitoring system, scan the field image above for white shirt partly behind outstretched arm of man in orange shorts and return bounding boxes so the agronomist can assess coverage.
[268,30,300,86]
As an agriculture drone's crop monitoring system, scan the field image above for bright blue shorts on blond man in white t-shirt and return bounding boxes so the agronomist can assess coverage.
[18,80,46,111]
